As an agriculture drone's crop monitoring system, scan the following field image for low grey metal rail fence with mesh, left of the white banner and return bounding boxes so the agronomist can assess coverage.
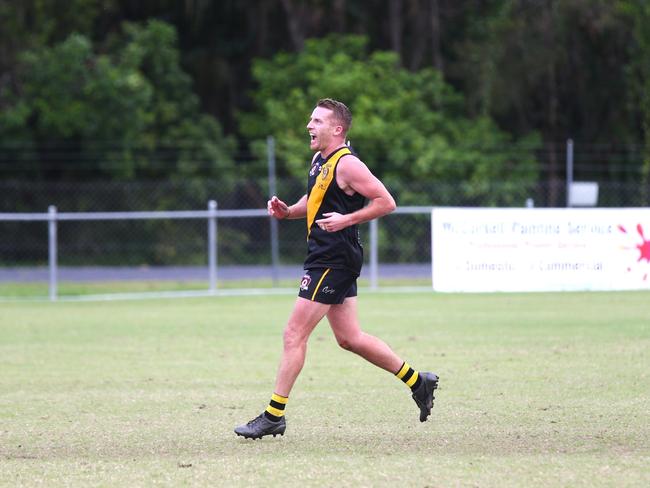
[0,202,431,299]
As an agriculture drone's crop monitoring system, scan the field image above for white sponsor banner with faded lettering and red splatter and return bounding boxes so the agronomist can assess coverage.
[431,207,650,292]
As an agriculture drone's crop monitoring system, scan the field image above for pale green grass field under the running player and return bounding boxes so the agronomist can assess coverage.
[0,292,650,487]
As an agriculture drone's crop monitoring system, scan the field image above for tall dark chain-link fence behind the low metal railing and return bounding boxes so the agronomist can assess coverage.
[0,136,650,296]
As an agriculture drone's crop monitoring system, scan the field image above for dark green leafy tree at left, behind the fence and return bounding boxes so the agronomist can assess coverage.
[0,21,234,179]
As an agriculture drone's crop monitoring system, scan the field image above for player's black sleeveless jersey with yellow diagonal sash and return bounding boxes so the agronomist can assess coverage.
[305,147,365,275]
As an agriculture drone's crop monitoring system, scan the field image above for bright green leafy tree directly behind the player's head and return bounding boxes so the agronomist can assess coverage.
[241,36,539,201]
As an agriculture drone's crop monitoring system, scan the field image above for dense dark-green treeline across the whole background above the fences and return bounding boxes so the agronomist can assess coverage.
[0,0,650,194]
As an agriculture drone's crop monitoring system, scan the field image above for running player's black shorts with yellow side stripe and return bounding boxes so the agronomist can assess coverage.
[298,268,357,305]
